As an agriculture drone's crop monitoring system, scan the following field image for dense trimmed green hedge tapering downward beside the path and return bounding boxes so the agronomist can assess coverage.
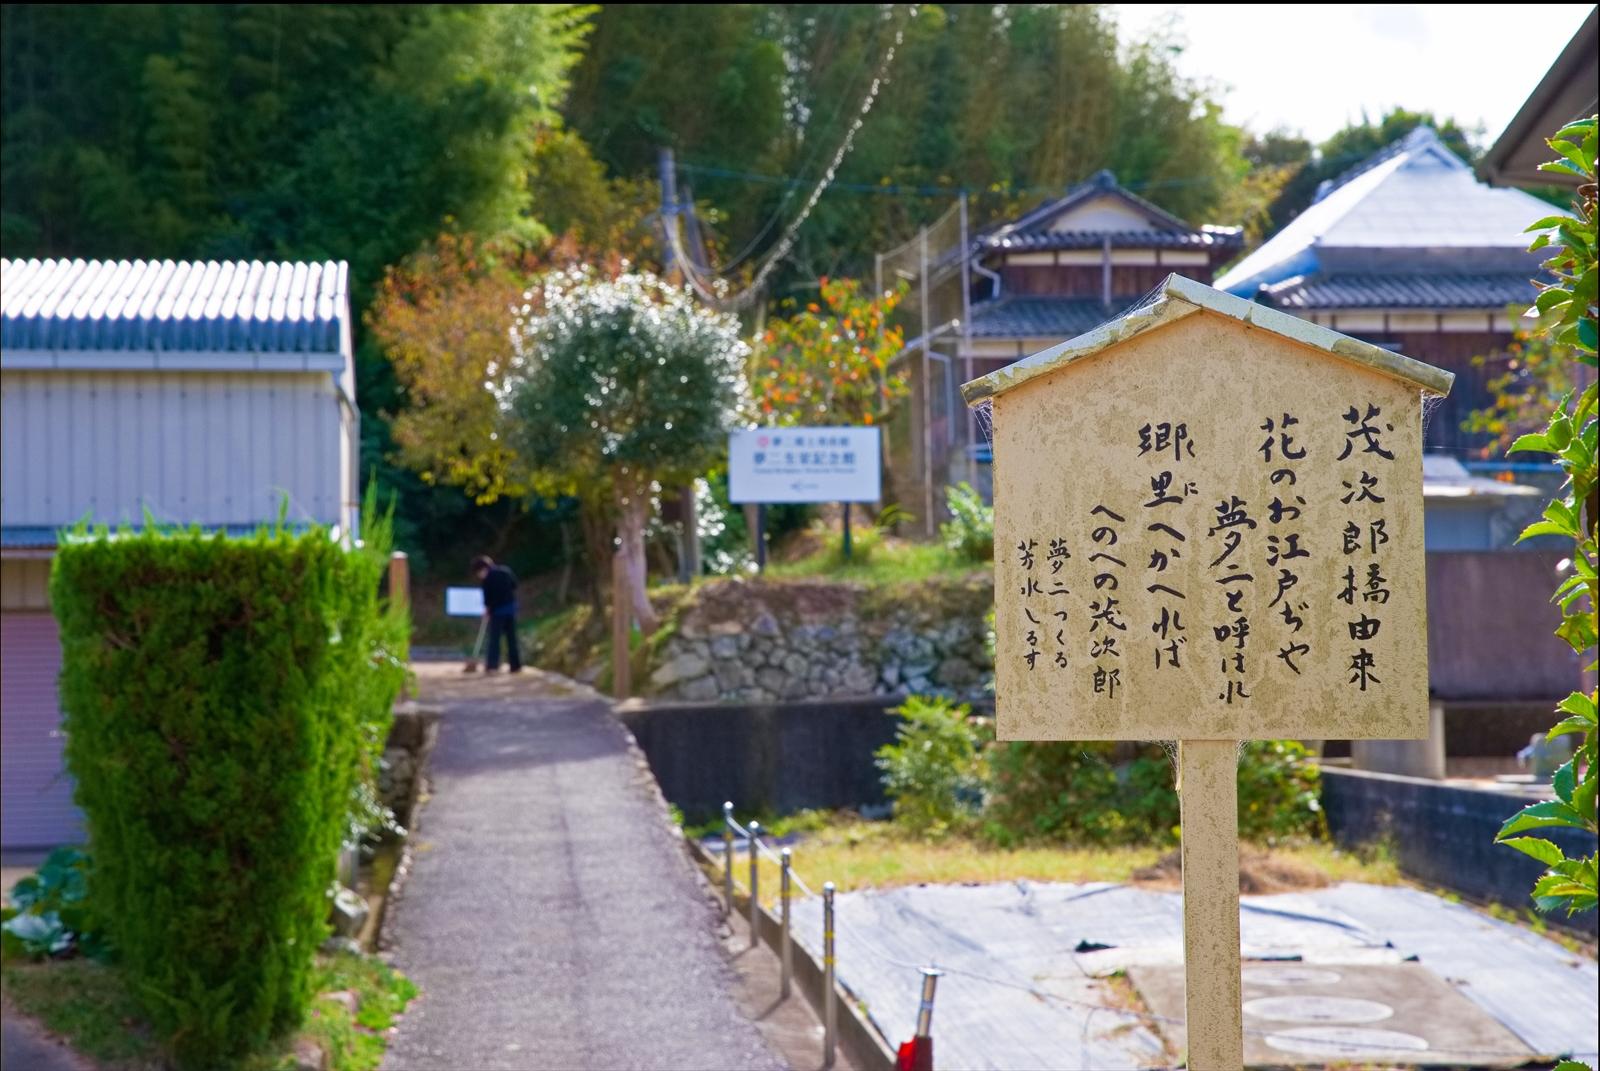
[50,512,405,1068]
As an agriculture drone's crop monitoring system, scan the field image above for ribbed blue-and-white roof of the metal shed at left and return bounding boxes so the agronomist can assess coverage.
[0,259,350,354]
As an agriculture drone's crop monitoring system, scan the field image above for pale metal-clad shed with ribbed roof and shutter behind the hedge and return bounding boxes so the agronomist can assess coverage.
[0,259,360,852]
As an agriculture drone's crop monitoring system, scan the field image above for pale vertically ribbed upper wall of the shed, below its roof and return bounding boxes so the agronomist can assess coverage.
[0,371,347,527]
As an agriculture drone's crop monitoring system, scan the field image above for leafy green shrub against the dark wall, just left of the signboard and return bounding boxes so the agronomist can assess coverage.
[877,695,986,834]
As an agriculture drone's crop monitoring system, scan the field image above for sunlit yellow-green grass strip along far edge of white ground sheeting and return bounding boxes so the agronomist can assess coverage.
[707,812,1400,905]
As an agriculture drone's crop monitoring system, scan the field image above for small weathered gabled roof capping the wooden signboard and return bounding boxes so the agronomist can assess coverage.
[962,275,1456,405]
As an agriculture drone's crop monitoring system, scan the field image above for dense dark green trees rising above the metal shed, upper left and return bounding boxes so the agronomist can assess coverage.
[0,3,590,566]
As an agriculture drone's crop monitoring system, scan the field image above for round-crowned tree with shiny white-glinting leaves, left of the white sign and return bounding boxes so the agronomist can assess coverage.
[498,267,749,632]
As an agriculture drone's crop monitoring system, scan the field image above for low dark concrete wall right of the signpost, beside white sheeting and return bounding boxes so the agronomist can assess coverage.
[1322,767,1595,932]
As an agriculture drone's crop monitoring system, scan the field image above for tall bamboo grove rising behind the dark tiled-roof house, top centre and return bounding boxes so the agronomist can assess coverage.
[565,3,1245,290]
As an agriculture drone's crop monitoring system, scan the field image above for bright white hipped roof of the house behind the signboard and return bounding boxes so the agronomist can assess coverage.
[1216,126,1550,296]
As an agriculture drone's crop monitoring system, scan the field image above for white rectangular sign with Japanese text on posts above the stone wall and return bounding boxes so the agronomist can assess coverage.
[728,427,883,503]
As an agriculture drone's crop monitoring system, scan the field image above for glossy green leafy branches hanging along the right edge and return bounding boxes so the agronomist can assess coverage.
[1498,117,1600,914]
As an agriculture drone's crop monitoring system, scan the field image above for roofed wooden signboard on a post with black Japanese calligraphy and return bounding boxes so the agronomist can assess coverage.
[963,275,1453,1068]
